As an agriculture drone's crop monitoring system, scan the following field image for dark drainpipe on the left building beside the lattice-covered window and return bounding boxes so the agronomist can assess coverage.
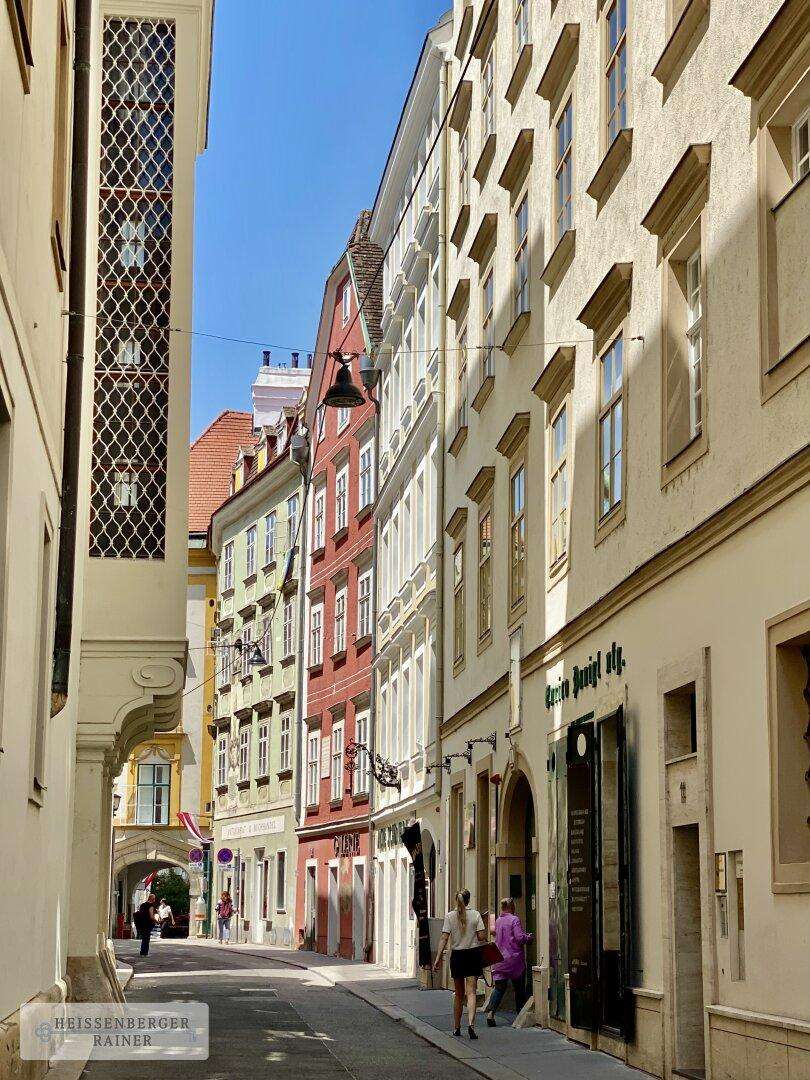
[51,0,92,716]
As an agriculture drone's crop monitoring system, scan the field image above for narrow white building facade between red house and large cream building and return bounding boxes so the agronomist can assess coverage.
[369,12,451,972]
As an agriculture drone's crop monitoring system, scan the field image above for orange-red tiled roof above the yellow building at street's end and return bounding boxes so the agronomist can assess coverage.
[188,409,254,532]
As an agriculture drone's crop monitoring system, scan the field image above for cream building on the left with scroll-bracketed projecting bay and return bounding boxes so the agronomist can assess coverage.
[0,0,212,1076]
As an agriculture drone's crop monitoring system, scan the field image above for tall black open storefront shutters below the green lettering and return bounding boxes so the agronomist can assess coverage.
[566,708,633,1038]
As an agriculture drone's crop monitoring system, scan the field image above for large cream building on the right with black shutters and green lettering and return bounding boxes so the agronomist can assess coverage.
[442,0,810,1080]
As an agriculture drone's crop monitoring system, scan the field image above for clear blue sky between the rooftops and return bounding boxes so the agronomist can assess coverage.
[191,0,450,437]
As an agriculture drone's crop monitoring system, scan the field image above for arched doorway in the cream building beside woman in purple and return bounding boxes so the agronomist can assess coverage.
[498,761,538,971]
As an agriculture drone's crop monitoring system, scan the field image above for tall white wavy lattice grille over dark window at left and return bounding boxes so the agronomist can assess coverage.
[90,18,175,558]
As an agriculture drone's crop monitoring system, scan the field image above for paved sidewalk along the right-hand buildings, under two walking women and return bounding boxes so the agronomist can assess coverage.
[188,937,647,1080]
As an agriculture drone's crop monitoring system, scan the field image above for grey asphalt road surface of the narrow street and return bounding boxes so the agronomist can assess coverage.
[82,941,477,1080]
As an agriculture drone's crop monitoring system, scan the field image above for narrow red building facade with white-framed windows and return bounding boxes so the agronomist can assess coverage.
[296,212,381,959]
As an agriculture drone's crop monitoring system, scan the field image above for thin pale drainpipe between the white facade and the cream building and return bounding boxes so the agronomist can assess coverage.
[432,52,448,812]
